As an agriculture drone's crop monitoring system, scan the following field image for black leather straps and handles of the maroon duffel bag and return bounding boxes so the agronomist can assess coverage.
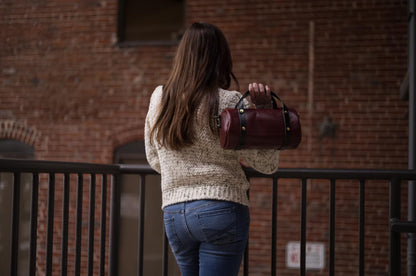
[235,91,292,150]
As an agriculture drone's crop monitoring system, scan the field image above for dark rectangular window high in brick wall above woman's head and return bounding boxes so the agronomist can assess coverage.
[118,0,185,45]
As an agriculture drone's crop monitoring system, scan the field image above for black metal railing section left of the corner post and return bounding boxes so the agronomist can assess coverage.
[0,159,120,276]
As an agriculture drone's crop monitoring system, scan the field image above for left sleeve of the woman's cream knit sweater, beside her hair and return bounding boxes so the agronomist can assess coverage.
[144,86,162,173]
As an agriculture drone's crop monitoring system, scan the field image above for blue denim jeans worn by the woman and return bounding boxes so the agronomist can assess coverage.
[163,200,250,276]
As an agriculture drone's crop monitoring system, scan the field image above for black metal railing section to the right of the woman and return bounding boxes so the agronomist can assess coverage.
[246,169,416,276]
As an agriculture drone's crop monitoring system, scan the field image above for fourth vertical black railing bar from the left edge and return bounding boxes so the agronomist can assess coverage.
[61,173,69,276]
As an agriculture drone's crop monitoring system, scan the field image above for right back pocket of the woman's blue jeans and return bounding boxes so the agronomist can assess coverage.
[196,206,237,244]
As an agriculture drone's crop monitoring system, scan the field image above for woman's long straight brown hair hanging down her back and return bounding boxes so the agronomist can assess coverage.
[150,23,238,150]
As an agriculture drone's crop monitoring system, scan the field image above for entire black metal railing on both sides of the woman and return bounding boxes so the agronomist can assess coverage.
[0,159,416,276]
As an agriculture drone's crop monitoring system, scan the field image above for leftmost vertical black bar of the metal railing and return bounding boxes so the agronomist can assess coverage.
[10,173,20,276]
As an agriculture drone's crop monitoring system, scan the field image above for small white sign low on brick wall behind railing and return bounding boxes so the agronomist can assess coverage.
[286,242,325,269]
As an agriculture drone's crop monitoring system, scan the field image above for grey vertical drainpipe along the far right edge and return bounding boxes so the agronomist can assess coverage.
[407,0,416,275]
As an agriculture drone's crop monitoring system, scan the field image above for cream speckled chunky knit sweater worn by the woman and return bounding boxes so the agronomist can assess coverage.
[145,86,279,209]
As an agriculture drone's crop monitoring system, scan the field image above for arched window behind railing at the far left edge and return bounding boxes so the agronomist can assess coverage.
[0,139,34,275]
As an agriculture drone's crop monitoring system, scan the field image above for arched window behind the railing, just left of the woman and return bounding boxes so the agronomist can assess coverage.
[114,141,180,276]
